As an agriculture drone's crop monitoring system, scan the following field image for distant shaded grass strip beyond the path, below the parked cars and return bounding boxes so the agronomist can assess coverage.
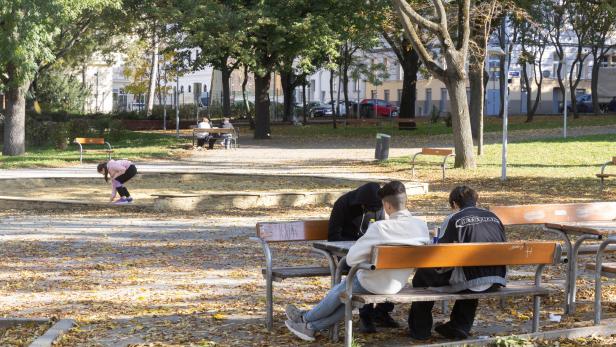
[272,115,616,138]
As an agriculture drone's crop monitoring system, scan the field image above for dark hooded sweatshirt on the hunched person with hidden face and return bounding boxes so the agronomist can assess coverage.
[327,183,383,241]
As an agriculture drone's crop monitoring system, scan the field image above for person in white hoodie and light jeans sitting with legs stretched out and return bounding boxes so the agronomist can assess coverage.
[285,181,430,341]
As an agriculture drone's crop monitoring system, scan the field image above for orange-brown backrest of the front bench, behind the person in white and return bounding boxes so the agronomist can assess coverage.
[372,241,561,269]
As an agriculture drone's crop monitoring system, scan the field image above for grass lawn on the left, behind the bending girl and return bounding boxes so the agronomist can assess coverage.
[0,132,188,169]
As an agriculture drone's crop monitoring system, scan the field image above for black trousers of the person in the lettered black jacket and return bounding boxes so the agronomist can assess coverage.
[409,269,482,338]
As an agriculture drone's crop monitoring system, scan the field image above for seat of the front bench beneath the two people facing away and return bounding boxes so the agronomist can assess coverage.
[342,283,555,304]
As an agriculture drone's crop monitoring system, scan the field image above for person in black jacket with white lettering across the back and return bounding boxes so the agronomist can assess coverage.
[408,186,507,340]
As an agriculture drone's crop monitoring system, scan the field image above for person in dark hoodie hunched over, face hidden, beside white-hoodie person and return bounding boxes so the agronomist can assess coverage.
[327,182,400,333]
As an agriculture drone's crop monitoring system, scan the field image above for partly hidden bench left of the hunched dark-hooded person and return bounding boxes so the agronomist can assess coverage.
[255,220,336,330]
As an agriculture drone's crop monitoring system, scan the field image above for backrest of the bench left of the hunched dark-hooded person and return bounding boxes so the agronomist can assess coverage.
[257,219,329,242]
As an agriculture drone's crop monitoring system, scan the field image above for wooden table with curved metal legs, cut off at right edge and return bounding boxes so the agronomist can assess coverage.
[545,221,616,324]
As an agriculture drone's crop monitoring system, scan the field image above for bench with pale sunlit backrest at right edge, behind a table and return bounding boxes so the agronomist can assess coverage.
[490,202,616,313]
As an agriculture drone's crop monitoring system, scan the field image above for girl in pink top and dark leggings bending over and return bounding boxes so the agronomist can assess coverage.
[96,160,137,205]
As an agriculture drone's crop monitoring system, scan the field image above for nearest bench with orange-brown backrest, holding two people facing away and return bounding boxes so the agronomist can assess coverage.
[340,242,561,347]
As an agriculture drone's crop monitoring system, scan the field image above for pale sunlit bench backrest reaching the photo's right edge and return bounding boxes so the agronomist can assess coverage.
[490,202,616,225]
